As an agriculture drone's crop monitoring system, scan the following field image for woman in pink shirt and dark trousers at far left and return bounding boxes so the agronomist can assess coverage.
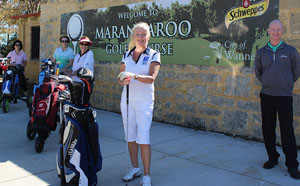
[6,40,28,103]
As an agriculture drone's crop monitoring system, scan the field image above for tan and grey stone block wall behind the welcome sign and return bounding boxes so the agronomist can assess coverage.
[40,0,300,146]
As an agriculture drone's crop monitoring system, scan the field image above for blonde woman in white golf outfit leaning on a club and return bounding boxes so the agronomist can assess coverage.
[118,22,161,186]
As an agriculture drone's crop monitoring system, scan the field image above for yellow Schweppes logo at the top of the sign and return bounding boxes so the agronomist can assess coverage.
[225,0,270,29]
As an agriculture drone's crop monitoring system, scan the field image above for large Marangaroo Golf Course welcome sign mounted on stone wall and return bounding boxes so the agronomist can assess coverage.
[61,0,279,66]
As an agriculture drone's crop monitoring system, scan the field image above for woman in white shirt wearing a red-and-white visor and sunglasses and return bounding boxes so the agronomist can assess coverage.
[72,36,94,75]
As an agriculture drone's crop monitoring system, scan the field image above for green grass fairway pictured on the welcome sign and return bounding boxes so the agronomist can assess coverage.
[86,34,268,66]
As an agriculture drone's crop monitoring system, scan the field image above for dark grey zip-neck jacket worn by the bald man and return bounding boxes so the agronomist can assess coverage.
[254,42,300,96]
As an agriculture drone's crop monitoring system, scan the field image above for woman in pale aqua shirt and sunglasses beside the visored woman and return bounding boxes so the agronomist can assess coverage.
[52,36,74,74]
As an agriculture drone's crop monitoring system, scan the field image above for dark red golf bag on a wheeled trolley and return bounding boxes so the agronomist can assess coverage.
[27,76,59,152]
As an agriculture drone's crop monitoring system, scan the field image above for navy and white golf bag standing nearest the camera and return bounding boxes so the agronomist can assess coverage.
[56,69,102,186]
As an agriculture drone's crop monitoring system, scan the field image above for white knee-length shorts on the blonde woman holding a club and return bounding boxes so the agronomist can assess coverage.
[121,99,154,144]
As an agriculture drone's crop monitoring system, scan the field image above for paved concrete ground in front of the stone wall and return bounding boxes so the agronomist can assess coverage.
[0,102,300,186]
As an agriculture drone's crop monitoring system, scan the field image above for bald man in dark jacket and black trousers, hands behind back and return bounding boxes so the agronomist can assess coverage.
[255,20,300,179]
